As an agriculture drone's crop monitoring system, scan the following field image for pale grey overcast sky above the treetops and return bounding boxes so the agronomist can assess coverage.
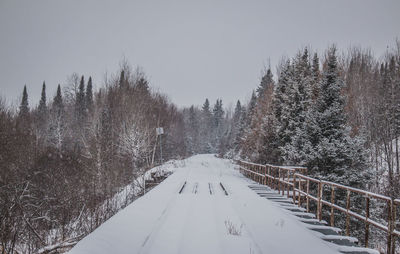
[0,0,400,106]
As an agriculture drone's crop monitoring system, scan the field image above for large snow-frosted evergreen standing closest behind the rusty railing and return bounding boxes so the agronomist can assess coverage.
[306,47,368,187]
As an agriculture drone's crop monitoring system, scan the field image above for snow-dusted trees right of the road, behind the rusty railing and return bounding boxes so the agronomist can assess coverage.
[219,41,400,250]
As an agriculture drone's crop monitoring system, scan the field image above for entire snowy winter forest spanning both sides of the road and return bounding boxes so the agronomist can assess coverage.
[0,41,400,253]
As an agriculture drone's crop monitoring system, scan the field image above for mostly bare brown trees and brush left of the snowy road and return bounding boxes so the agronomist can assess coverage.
[0,65,186,253]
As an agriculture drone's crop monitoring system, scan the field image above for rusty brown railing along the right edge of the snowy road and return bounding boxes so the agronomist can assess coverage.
[236,161,400,254]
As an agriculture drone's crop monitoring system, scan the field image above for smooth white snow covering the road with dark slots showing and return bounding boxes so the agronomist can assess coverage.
[69,155,338,254]
